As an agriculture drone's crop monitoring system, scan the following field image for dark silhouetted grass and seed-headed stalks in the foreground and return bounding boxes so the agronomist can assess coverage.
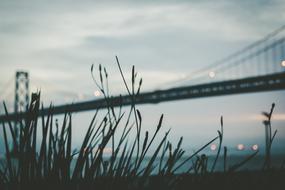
[0,57,284,190]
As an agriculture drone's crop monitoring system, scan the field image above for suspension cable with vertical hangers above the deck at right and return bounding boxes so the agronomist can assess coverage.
[162,25,285,86]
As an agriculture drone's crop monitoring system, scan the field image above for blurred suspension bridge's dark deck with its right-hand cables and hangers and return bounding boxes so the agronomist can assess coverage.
[0,25,285,122]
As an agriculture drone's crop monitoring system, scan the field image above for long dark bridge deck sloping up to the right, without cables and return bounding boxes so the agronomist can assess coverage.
[0,72,285,121]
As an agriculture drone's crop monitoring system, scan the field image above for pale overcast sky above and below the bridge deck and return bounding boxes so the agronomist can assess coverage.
[0,0,285,154]
